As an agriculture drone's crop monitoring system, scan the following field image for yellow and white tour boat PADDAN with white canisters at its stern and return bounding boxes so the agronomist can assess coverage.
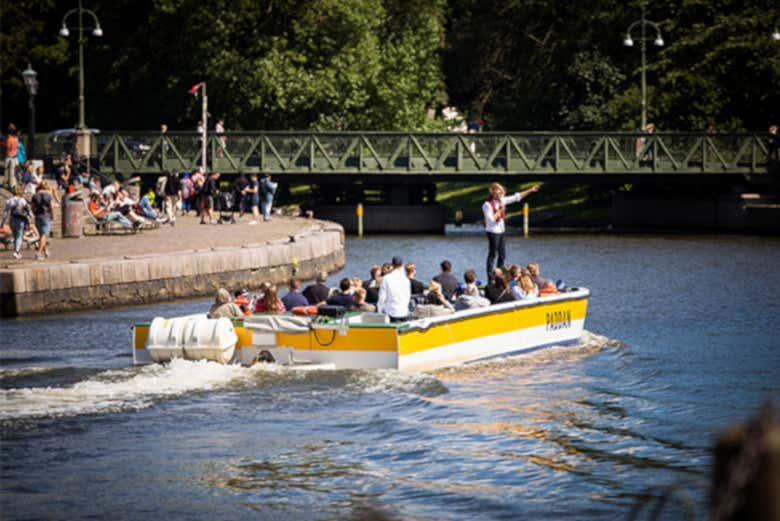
[133,288,590,371]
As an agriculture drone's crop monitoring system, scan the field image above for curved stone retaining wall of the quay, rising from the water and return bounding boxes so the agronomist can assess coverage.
[0,221,344,317]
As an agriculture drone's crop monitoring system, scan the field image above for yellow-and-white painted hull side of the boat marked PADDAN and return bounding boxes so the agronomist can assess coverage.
[133,289,589,371]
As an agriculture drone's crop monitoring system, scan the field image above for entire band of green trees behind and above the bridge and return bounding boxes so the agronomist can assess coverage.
[0,0,780,131]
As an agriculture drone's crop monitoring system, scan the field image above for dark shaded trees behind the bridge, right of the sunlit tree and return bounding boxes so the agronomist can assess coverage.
[445,0,780,130]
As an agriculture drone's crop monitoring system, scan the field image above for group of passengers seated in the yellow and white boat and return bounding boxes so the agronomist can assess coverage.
[209,257,561,322]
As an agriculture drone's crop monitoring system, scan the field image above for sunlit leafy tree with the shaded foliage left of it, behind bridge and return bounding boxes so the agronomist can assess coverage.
[2,0,446,130]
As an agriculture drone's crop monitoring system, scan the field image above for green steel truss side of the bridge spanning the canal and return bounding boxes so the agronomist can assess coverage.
[70,131,768,182]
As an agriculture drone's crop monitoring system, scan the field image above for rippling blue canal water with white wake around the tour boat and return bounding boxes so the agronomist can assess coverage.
[0,233,780,521]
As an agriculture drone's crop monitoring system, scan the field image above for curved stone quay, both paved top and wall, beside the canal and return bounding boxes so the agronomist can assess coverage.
[0,216,345,318]
